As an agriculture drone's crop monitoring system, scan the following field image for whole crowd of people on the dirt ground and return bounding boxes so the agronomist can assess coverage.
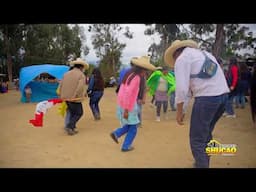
[1,40,256,168]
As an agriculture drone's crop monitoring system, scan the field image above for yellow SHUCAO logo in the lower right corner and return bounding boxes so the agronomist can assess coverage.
[205,139,237,156]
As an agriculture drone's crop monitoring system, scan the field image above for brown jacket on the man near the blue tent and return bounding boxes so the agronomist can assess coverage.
[60,68,85,102]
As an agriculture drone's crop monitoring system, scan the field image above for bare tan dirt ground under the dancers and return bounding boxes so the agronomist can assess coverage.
[0,88,256,168]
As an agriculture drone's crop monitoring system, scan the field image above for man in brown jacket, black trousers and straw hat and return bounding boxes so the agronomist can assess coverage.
[60,58,89,135]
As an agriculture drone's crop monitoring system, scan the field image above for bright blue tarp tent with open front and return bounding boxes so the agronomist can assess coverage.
[19,64,69,102]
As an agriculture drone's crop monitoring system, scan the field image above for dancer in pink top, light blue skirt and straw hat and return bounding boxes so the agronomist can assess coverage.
[110,56,155,152]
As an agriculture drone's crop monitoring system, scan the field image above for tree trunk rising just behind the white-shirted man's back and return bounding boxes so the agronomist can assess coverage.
[212,24,224,58]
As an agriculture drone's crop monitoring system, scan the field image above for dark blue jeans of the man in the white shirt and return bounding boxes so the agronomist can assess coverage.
[189,94,228,168]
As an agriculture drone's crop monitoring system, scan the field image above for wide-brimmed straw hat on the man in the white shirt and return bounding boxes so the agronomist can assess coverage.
[164,40,198,67]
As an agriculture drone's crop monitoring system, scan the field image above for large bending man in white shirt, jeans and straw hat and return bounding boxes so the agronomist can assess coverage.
[164,40,229,168]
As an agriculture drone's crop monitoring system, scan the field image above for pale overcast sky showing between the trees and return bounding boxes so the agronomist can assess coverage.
[81,24,256,64]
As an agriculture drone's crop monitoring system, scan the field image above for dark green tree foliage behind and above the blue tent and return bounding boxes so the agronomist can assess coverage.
[0,24,89,79]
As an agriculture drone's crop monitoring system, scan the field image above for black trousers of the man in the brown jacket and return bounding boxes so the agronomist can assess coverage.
[66,101,83,129]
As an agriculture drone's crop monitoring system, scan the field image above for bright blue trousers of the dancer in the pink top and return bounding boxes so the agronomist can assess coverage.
[113,124,137,150]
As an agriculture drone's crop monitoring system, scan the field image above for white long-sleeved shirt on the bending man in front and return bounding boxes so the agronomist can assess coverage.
[174,47,229,106]
